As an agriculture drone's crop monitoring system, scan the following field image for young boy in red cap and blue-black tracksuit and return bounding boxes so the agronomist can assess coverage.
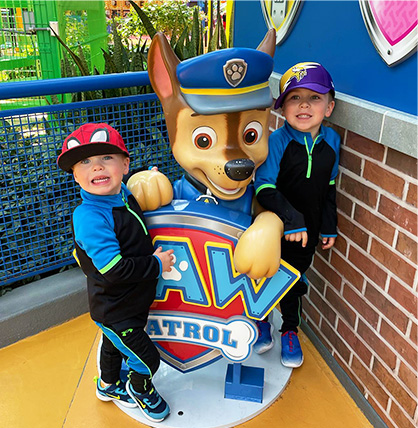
[57,123,174,422]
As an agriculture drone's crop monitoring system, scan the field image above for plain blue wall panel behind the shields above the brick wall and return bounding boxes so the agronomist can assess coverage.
[234,0,417,115]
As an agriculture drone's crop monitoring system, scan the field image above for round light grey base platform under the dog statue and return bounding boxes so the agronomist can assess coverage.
[108,309,292,428]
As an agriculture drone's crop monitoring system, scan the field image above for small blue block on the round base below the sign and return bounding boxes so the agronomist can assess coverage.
[225,363,264,403]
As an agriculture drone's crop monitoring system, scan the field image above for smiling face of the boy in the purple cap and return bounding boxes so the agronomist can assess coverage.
[282,88,335,139]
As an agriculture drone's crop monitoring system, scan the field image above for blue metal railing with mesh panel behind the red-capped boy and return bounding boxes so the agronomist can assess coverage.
[0,72,181,286]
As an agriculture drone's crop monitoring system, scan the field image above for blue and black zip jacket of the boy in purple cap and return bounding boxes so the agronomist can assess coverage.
[255,122,340,250]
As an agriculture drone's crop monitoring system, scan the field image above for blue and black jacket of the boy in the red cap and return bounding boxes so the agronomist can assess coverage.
[72,184,161,324]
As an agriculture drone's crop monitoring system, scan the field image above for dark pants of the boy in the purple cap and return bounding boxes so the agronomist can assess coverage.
[280,239,315,333]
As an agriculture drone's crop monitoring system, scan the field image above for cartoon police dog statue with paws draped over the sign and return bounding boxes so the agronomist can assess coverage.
[128,30,283,279]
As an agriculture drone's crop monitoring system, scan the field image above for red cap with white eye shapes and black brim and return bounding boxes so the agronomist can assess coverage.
[57,123,129,172]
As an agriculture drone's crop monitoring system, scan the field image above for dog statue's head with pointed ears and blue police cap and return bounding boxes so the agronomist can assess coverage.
[148,30,275,200]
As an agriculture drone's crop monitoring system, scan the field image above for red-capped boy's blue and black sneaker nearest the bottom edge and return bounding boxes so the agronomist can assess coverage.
[126,380,170,422]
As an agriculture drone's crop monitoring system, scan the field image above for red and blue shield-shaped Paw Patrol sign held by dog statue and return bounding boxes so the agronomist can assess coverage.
[145,200,299,372]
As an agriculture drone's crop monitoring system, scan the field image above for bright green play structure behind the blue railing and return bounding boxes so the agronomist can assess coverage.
[0,0,108,109]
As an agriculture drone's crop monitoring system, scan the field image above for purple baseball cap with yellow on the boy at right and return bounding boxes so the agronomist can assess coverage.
[274,62,335,108]
